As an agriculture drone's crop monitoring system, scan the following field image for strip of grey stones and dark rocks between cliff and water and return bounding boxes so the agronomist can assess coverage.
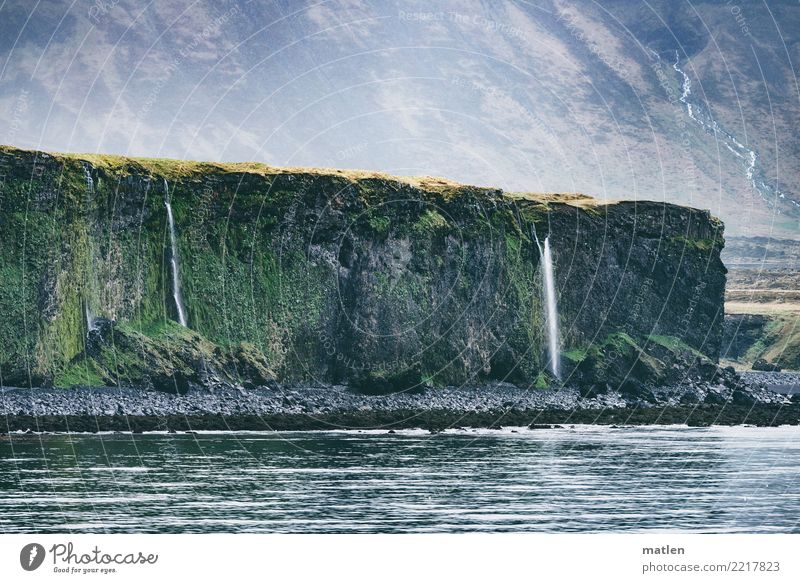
[0,373,800,432]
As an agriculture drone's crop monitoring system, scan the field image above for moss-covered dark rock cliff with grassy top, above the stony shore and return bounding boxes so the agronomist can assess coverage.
[0,148,725,390]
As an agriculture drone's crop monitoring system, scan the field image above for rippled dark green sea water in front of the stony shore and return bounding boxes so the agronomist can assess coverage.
[0,426,800,533]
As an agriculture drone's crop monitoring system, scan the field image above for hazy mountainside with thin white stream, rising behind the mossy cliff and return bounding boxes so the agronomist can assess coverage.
[0,0,800,238]
